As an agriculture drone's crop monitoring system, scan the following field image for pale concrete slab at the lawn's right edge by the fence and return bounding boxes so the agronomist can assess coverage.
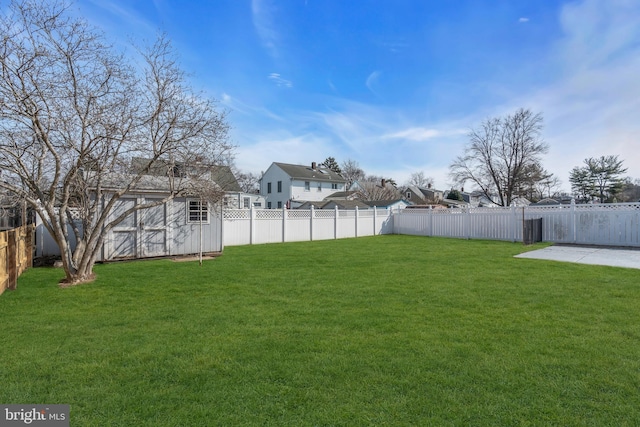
[516,245,640,269]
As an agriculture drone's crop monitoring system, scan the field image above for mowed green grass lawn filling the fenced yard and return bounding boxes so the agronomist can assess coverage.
[0,236,640,426]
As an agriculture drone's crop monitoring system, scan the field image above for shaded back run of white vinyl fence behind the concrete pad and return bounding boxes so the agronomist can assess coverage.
[393,203,640,247]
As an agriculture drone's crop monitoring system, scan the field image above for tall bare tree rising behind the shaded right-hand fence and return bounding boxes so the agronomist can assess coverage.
[450,108,548,206]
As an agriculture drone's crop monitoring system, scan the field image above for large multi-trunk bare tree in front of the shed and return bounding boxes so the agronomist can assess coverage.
[0,0,232,283]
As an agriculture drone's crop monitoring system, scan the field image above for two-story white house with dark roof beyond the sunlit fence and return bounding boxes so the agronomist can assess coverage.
[260,162,346,209]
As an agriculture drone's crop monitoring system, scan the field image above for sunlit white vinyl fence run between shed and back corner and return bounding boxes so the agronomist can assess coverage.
[223,208,393,246]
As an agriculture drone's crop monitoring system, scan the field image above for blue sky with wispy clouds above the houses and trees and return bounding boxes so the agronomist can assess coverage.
[74,0,640,191]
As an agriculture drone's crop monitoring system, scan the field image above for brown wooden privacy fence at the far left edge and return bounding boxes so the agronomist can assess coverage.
[0,224,34,294]
